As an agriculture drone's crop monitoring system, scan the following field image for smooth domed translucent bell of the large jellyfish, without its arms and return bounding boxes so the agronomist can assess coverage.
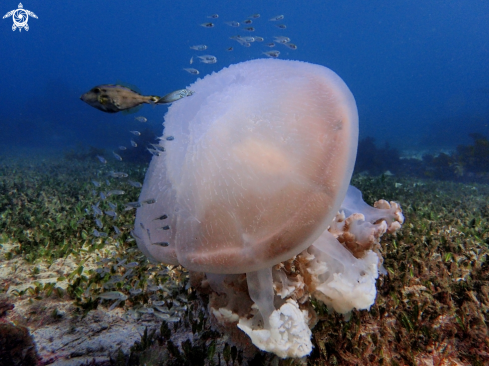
[135,59,358,274]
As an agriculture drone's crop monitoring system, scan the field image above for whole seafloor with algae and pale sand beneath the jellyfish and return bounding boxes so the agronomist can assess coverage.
[0,151,489,366]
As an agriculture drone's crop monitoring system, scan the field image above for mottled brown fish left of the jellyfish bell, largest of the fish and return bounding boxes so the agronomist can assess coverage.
[80,84,160,113]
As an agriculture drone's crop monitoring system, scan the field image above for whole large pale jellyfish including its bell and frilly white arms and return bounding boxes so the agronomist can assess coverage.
[134,59,402,357]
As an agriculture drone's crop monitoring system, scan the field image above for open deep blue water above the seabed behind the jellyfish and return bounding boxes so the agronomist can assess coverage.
[0,0,489,149]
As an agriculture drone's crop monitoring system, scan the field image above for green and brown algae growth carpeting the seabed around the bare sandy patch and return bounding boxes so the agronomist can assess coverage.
[0,153,489,365]
